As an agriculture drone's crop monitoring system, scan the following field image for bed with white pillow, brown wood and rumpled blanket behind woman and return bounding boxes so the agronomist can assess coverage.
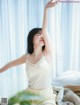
[52,71,80,105]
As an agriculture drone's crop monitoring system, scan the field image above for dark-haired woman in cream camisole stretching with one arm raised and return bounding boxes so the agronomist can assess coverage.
[0,0,58,105]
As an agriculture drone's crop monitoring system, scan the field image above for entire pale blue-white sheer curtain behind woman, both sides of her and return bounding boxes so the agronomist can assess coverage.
[0,0,80,97]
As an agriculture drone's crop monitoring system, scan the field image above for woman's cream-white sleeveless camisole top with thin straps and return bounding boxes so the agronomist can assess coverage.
[26,56,52,89]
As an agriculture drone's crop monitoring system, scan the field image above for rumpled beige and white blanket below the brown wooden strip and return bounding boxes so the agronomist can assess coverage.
[53,86,80,105]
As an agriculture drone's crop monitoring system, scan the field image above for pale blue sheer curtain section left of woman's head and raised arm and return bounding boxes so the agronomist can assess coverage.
[0,0,46,97]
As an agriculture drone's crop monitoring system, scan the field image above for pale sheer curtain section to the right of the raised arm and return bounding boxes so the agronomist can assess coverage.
[49,3,80,78]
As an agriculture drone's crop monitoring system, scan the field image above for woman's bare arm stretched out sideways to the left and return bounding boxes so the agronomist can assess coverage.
[0,54,27,73]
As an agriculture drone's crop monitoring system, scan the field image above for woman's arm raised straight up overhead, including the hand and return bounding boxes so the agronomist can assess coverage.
[42,0,59,55]
